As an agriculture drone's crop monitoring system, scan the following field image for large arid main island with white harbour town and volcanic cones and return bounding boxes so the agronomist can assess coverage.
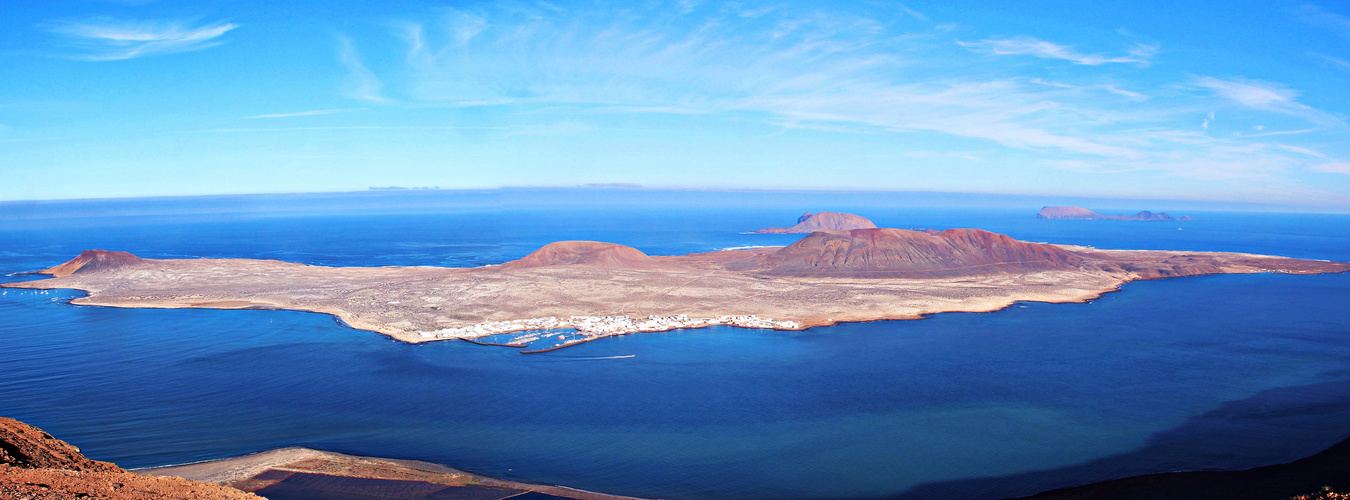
[0,222,1350,351]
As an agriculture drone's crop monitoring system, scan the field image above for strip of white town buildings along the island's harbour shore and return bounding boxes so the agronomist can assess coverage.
[419,315,802,338]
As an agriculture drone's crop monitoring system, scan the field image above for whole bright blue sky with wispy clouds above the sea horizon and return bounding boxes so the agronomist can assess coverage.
[0,0,1350,206]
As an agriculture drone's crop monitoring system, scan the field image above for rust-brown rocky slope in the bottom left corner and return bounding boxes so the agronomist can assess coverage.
[0,418,259,500]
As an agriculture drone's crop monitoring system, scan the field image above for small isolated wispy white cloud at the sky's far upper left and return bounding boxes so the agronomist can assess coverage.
[42,18,239,61]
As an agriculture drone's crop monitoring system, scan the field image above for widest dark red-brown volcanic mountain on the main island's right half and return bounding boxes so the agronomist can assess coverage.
[728,228,1083,278]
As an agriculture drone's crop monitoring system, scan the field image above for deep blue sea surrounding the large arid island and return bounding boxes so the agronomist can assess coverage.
[0,191,1350,499]
